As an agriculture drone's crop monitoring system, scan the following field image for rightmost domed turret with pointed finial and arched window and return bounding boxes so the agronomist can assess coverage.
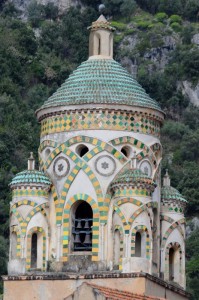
[160,170,187,287]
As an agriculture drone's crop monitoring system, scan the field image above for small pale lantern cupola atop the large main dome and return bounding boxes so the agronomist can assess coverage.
[88,15,115,58]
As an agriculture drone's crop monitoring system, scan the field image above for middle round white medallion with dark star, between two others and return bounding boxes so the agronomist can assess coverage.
[95,155,116,176]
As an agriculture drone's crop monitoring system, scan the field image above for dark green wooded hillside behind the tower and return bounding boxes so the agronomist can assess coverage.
[0,0,199,300]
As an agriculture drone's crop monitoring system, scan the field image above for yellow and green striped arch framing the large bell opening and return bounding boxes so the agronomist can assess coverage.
[62,193,100,261]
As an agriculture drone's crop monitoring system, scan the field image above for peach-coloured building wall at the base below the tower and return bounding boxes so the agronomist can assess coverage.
[3,273,189,300]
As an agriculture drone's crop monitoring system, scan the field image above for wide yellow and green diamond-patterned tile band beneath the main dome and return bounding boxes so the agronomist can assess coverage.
[41,110,160,136]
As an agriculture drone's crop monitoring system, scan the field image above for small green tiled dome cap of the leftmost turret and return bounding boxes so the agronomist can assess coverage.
[9,170,51,186]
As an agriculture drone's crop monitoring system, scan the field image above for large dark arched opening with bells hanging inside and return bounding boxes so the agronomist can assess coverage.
[71,200,93,251]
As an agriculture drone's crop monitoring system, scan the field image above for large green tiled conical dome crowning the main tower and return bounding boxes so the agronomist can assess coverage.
[41,58,161,111]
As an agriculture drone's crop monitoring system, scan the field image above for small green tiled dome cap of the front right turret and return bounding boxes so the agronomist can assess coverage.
[112,169,155,185]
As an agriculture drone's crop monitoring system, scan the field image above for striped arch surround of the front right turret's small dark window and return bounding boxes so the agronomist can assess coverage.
[131,225,151,259]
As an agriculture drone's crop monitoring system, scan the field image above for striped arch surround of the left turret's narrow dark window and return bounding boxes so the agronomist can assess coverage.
[26,227,46,271]
